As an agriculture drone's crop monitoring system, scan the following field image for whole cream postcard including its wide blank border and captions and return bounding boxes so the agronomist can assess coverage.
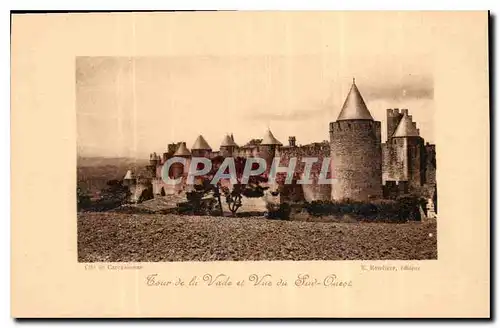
[10,11,492,318]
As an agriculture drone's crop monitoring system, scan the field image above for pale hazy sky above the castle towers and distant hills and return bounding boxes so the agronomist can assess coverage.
[76,14,434,156]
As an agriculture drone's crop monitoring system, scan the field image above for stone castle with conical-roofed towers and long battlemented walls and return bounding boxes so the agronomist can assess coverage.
[125,80,436,215]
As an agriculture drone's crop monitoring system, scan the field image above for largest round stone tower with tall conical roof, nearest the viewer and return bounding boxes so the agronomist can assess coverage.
[330,80,382,201]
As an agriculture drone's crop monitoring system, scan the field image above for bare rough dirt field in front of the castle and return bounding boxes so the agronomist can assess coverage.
[78,212,437,262]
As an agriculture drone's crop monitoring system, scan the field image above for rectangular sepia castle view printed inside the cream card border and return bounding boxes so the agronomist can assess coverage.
[75,53,438,262]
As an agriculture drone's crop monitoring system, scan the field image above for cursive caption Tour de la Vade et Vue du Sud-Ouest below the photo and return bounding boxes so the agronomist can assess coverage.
[145,273,352,288]
